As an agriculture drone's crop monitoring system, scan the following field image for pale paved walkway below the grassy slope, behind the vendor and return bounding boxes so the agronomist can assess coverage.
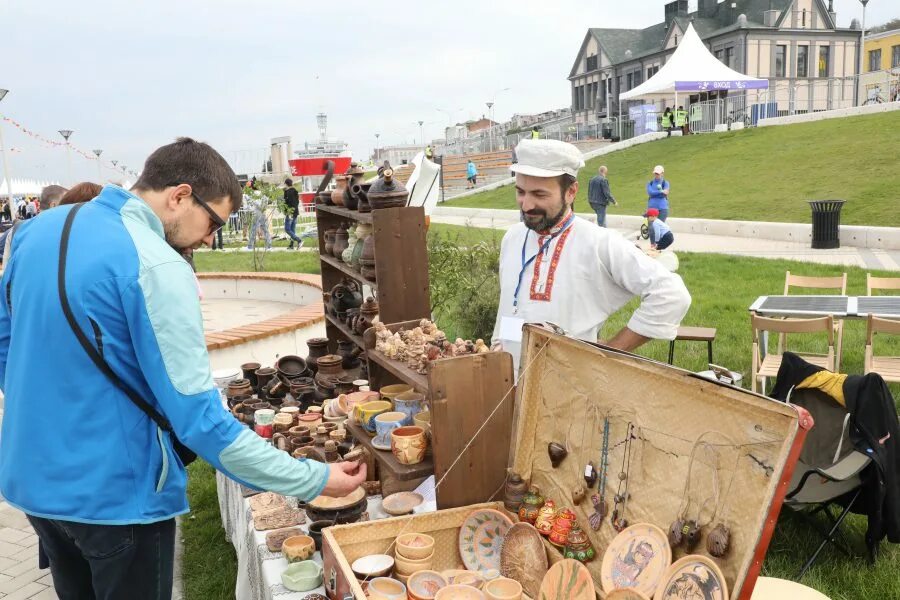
[431,210,900,271]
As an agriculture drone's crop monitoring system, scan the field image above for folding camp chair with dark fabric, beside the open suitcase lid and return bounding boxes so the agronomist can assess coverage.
[784,388,874,579]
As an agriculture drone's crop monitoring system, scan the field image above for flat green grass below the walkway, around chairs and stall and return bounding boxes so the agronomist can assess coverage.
[184,237,900,600]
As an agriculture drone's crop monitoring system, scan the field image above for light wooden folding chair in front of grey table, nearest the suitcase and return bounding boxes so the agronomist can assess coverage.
[750,314,835,393]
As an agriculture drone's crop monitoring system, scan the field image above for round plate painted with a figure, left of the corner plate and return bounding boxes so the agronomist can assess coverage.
[600,523,672,598]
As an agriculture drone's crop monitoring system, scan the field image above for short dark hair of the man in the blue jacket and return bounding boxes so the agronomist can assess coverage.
[133,137,243,212]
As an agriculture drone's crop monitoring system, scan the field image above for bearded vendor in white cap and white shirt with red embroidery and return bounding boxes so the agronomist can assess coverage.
[491,140,691,371]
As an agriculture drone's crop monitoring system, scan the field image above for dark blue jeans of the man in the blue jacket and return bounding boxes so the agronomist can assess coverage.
[28,515,175,600]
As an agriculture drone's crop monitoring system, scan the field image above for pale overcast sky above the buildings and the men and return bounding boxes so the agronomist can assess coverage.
[0,0,900,182]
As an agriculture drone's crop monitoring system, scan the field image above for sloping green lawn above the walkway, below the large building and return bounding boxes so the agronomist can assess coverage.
[446,112,900,226]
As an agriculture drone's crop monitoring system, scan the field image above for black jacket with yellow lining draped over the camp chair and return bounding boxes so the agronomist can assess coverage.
[771,352,900,552]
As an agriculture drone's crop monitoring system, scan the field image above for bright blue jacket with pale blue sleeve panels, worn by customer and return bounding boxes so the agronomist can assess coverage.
[0,186,328,525]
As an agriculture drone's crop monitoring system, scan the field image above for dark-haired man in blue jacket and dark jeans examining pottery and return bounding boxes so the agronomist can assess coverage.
[0,138,365,600]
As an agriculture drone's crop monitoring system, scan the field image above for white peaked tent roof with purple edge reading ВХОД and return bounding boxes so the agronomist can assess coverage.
[619,23,769,104]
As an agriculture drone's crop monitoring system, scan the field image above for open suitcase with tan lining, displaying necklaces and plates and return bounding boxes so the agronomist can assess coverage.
[323,325,813,600]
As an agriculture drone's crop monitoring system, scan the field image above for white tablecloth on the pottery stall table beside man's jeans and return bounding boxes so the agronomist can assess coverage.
[216,473,388,600]
